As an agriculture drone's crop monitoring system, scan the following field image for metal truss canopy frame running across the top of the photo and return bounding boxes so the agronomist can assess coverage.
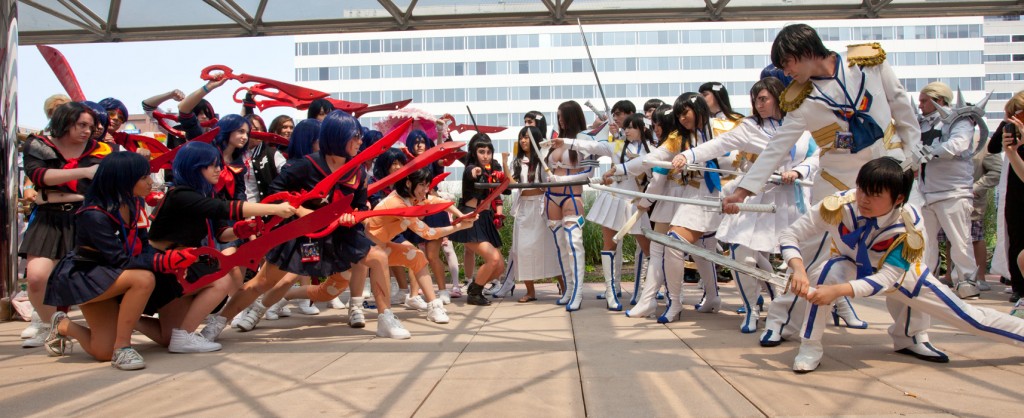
[17,0,1024,45]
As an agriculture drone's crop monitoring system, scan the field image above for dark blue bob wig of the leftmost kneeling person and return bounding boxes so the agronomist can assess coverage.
[83,153,150,224]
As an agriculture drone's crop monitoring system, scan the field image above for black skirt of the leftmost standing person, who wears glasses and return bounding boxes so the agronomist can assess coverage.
[17,202,82,260]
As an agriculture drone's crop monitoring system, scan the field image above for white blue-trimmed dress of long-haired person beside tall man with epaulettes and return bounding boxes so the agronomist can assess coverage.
[680,118,818,253]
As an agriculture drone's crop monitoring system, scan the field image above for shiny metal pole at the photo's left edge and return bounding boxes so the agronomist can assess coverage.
[0,0,19,320]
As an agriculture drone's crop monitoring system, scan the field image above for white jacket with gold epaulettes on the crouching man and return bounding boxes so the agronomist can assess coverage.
[779,190,927,297]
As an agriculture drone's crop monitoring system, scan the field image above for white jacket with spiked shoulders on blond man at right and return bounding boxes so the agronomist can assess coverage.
[918,112,974,204]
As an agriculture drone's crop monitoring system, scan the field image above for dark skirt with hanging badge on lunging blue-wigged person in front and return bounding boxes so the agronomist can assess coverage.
[266,224,374,278]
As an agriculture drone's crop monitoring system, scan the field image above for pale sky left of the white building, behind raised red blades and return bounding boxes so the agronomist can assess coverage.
[17,36,296,129]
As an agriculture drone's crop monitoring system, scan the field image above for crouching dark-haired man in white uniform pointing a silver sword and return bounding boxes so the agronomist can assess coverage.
[779,157,1024,372]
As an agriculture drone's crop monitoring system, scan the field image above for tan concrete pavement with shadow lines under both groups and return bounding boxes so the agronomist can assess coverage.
[0,284,1024,418]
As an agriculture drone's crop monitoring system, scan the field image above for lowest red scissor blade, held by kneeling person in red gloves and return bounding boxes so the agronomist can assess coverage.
[179,193,352,294]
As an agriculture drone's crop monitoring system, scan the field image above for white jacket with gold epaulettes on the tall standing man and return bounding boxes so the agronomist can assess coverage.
[739,43,921,201]
